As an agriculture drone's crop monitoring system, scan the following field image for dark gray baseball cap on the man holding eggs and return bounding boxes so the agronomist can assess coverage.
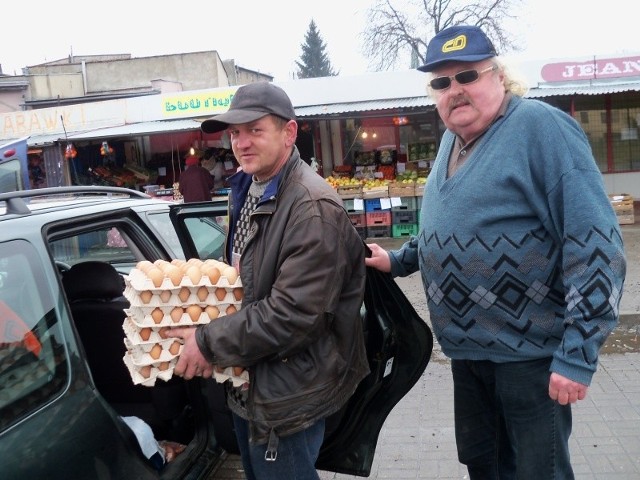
[200,82,296,133]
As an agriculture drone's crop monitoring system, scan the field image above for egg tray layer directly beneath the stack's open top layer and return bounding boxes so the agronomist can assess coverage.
[124,285,242,307]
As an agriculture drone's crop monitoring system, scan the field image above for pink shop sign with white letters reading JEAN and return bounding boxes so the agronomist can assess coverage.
[542,56,640,82]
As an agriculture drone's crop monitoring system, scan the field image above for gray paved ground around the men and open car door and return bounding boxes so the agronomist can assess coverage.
[211,216,640,480]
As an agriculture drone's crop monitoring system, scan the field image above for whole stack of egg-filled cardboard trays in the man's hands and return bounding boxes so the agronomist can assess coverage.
[122,258,248,386]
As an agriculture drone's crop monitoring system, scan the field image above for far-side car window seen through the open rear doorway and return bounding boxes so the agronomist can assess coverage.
[51,226,137,268]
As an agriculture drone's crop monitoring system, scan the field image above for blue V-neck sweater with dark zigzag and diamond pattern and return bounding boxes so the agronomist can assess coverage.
[391,97,626,385]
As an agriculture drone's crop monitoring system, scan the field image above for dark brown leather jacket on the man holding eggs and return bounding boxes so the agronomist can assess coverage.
[196,147,369,444]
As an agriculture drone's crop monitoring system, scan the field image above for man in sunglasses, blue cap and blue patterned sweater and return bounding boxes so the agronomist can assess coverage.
[366,26,626,480]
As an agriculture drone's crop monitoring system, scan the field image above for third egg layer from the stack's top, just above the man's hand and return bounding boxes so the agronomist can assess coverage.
[125,302,240,328]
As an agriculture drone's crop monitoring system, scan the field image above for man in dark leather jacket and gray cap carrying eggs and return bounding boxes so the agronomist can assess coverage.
[171,82,369,480]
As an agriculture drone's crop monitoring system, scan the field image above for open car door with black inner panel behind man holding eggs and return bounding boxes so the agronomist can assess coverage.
[170,201,433,477]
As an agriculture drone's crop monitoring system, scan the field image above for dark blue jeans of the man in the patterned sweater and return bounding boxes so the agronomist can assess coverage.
[451,358,574,480]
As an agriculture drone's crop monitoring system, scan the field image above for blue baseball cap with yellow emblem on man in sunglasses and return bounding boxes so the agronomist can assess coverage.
[418,25,498,72]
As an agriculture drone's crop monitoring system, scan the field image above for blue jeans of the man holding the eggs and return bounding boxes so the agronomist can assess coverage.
[233,414,325,480]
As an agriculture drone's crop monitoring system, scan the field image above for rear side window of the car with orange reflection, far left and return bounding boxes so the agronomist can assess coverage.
[0,240,68,431]
